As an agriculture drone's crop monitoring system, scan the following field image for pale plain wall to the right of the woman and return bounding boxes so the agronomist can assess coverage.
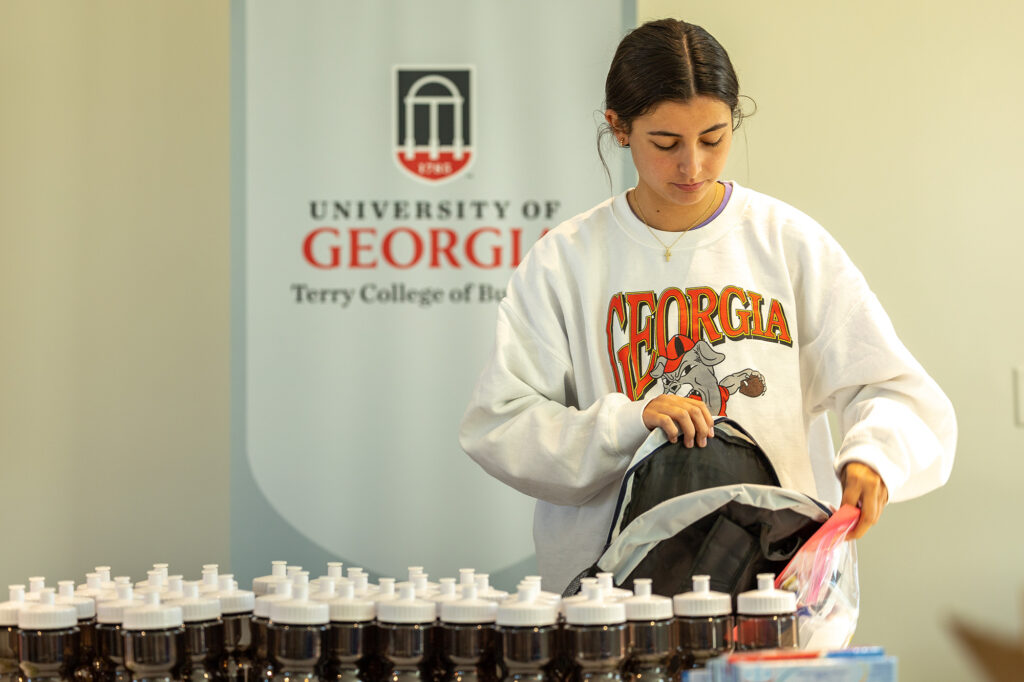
[638,0,1024,680]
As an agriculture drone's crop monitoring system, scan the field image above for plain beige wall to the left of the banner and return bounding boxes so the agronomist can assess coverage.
[0,0,229,585]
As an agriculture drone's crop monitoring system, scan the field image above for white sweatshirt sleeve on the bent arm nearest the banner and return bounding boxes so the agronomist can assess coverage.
[459,298,647,506]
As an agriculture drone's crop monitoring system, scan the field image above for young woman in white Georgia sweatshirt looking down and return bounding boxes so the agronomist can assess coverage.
[460,15,956,590]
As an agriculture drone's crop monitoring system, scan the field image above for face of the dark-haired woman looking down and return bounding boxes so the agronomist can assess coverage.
[605,95,732,220]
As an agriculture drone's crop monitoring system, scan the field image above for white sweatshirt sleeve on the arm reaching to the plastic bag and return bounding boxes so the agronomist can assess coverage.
[802,244,956,502]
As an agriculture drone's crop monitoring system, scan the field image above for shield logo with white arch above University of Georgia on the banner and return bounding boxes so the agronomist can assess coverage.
[392,66,475,184]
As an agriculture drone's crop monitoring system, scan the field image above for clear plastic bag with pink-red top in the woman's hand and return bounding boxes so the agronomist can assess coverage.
[775,505,860,650]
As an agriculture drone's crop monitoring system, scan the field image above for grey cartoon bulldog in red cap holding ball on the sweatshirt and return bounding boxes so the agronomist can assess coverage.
[650,334,767,417]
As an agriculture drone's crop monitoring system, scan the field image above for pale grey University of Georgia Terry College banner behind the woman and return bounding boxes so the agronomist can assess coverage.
[231,0,634,585]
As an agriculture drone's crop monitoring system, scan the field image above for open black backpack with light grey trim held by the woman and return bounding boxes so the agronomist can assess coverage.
[563,417,831,600]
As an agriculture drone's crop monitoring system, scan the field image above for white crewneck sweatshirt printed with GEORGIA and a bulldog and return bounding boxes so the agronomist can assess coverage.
[460,183,956,591]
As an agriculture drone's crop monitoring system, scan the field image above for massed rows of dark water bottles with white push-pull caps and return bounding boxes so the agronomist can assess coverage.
[0,561,797,682]
